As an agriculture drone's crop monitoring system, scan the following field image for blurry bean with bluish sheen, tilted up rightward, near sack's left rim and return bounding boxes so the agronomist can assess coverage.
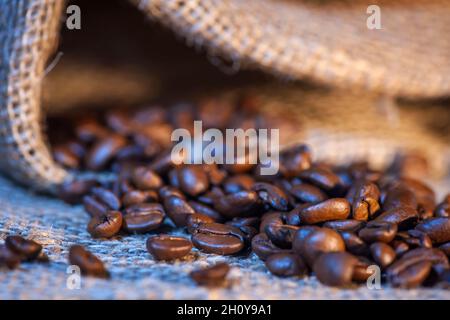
[86,135,127,171]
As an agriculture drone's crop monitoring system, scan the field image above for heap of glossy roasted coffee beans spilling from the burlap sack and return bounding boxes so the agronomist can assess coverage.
[54,98,450,288]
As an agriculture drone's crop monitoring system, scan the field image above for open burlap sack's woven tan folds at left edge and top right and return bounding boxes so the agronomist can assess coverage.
[0,0,450,191]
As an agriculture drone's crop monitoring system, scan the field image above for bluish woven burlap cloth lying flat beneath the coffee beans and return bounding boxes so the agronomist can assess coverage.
[0,172,450,299]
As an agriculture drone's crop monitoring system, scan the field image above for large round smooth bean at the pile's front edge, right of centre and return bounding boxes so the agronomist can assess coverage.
[313,252,358,287]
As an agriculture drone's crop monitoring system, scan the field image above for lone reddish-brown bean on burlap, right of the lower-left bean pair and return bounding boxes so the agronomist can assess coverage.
[69,245,110,278]
